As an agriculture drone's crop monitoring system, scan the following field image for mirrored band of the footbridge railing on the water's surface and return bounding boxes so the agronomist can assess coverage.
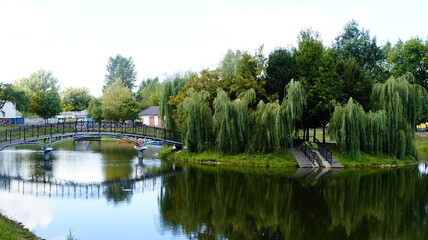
[0,169,182,199]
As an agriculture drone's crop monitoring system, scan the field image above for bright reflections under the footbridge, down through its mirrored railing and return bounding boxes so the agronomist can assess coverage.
[0,141,181,204]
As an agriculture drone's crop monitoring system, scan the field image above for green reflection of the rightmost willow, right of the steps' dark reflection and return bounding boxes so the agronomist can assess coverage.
[324,167,428,239]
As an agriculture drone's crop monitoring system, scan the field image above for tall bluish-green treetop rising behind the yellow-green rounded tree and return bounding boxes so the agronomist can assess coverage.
[103,54,137,91]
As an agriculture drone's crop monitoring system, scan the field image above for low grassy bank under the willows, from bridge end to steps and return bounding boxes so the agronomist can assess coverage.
[159,148,297,167]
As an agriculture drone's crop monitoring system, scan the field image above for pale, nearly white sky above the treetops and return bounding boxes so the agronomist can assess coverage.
[0,0,428,96]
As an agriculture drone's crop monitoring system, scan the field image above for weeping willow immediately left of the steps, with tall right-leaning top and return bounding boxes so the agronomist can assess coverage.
[249,80,306,152]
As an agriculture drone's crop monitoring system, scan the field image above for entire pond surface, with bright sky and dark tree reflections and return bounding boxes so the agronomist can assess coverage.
[0,141,428,240]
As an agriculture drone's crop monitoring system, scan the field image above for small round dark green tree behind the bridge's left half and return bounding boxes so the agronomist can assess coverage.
[29,89,61,119]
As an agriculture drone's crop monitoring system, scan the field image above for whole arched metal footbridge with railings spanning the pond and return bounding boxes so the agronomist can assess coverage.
[0,121,182,156]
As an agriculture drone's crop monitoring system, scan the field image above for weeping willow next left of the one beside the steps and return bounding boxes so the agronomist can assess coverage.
[213,88,256,154]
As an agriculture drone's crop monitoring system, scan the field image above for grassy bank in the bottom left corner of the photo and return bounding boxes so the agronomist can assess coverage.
[0,214,40,240]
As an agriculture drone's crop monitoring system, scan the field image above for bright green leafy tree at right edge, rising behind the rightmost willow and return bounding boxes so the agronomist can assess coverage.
[388,37,428,89]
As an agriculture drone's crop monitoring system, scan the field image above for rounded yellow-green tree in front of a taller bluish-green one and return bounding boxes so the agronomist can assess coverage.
[101,78,139,121]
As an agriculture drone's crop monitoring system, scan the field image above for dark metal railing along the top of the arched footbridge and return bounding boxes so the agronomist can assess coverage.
[0,121,181,143]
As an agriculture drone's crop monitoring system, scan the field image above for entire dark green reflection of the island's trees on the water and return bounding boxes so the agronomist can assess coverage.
[159,168,428,239]
